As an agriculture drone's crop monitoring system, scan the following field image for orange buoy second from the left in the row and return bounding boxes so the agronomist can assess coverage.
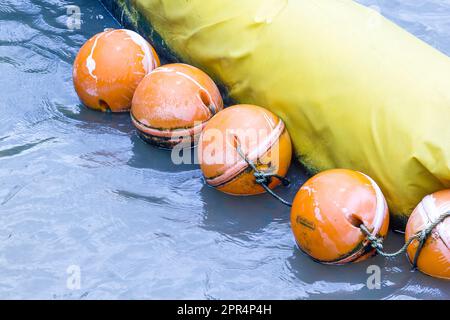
[131,63,223,148]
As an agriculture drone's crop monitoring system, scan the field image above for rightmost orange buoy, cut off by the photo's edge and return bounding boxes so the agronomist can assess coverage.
[405,189,450,280]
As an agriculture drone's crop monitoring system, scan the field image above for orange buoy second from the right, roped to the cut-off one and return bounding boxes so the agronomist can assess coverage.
[291,169,389,264]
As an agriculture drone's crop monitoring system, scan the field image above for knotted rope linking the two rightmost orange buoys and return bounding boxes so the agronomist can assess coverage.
[359,211,450,269]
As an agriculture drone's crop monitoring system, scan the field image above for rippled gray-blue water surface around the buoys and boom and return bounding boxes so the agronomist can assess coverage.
[0,0,450,299]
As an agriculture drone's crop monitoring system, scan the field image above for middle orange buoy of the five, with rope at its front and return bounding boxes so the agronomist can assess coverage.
[198,105,292,195]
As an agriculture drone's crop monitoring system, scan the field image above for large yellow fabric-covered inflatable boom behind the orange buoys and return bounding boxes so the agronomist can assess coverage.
[103,0,450,226]
